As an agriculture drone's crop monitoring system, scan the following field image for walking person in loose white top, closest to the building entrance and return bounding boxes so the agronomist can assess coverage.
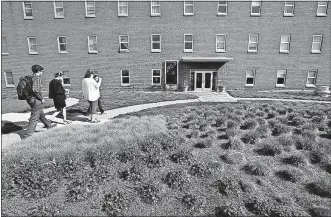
[82,69,102,123]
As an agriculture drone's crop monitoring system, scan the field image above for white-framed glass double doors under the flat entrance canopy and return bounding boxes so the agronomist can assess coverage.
[194,71,213,91]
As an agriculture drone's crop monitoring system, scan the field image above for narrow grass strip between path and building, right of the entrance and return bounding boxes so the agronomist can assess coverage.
[227,90,331,101]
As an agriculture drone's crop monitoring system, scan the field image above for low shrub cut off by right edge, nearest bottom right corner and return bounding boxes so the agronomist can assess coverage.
[306,179,331,198]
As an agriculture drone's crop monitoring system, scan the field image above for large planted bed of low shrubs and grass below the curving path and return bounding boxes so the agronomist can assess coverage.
[2,102,331,216]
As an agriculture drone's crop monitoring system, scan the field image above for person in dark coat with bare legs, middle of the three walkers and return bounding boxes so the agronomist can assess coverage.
[48,72,71,124]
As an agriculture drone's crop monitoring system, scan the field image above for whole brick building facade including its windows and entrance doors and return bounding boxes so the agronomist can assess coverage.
[1,0,331,93]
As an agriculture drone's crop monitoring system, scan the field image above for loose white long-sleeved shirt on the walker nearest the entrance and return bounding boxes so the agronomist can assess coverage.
[82,78,101,101]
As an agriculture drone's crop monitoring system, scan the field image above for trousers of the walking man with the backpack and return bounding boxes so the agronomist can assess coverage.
[26,97,52,135]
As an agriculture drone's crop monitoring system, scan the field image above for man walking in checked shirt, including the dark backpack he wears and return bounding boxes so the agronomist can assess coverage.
[17,65,56,138]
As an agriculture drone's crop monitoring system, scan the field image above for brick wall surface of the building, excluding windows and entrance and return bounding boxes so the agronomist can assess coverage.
[1,1,331,92]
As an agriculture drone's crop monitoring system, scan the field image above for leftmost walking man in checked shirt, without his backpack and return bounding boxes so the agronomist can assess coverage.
[23,65,56,138]
